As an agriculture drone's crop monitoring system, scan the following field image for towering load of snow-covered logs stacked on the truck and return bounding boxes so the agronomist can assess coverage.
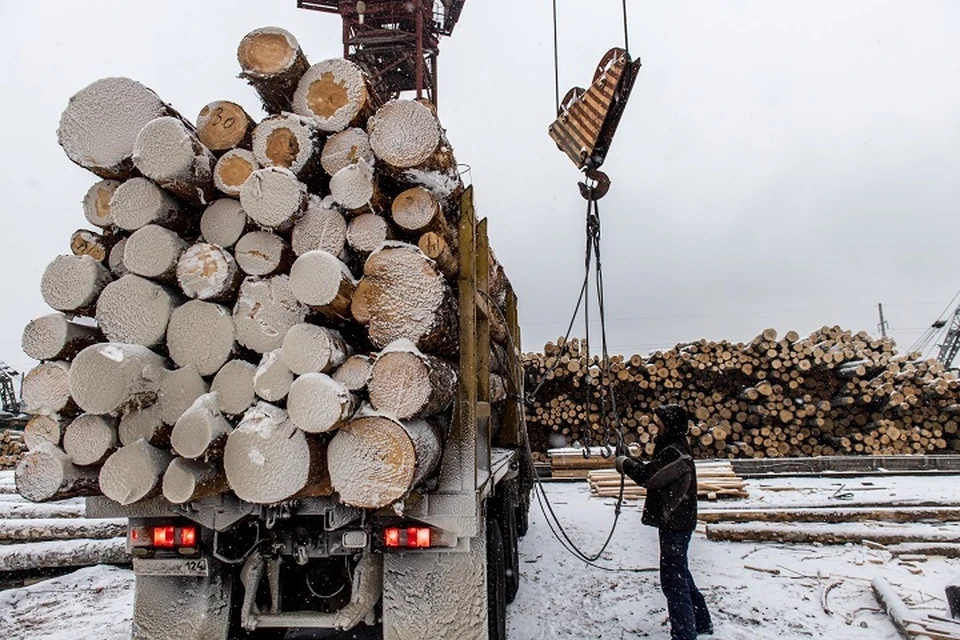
[16,28,509,509]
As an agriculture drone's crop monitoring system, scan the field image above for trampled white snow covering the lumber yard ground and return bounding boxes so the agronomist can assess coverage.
[0,472,960,640]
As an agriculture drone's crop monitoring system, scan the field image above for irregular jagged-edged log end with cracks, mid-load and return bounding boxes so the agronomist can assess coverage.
[233,275,307,353]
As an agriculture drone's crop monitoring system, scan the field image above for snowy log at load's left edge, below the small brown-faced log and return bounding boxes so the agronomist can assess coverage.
[40,256,113,316]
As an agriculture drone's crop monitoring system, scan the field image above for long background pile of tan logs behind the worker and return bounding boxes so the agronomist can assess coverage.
[524,327,960,460]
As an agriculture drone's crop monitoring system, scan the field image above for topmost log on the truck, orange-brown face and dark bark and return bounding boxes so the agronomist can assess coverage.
[237,27,310,113]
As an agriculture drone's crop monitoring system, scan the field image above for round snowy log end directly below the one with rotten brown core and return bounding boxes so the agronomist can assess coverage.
[240,167,307,231]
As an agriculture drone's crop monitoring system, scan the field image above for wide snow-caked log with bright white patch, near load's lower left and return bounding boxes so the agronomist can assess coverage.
[70,343,166,413]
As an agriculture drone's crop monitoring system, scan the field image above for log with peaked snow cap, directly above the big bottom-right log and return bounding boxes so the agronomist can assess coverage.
[367,339,457,420]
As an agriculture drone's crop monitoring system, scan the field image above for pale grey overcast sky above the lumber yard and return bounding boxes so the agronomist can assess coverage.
[0,0,960,370]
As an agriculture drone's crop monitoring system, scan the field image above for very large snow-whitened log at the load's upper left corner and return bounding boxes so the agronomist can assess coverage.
[57,78,174,180]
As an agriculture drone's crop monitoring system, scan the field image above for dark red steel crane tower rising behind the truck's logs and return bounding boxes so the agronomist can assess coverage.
[297,0,466,104]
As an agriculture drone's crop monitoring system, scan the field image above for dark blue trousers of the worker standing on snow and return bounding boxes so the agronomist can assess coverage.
[659,529,712,640]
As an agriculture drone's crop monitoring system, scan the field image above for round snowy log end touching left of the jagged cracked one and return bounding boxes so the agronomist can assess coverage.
[167,300,237,376]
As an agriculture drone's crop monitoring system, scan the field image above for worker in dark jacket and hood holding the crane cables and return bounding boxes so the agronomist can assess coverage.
[617,405,713,640]
